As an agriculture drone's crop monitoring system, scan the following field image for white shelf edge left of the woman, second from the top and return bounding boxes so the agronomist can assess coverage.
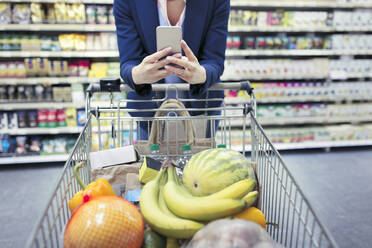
[0,51,119,58]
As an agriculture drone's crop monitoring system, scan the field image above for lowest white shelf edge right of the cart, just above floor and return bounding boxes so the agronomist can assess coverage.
[231,140,372,151]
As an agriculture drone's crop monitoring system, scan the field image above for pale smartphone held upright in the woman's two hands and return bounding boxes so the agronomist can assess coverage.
[156,26,182,54]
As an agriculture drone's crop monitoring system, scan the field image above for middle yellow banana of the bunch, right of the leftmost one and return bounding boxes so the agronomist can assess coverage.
[163,166,246,221]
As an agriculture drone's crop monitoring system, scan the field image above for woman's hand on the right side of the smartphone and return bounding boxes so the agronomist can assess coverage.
[164,40,207,84]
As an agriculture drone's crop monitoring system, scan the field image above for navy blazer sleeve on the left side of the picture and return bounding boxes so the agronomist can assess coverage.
[114,0,151,95]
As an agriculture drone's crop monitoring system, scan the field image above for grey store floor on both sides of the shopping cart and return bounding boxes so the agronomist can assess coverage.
[0,148,372,248]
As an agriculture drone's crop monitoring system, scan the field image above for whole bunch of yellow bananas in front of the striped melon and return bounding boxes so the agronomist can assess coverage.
[140,166,258,239]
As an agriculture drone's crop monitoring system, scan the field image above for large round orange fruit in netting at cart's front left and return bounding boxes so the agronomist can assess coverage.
[64,196,144,248]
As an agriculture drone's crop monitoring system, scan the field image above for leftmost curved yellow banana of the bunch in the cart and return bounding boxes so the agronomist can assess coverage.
[140,170,204,239]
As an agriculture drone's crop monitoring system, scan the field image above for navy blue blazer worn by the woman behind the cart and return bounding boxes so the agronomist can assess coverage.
[114,0,230,117]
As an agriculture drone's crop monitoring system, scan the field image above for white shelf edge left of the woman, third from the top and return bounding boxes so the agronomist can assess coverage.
[0,77,99,84]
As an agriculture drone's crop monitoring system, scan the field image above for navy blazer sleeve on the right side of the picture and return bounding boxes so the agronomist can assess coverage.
[191,0,230,95]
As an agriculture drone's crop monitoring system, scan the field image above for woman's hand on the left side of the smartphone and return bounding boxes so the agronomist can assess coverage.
[132,47,172,84]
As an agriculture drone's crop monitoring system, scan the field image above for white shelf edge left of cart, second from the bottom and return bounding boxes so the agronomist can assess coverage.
[0,127,83,135]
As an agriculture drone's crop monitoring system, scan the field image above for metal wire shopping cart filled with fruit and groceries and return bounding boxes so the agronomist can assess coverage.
[27,79,337,247]
